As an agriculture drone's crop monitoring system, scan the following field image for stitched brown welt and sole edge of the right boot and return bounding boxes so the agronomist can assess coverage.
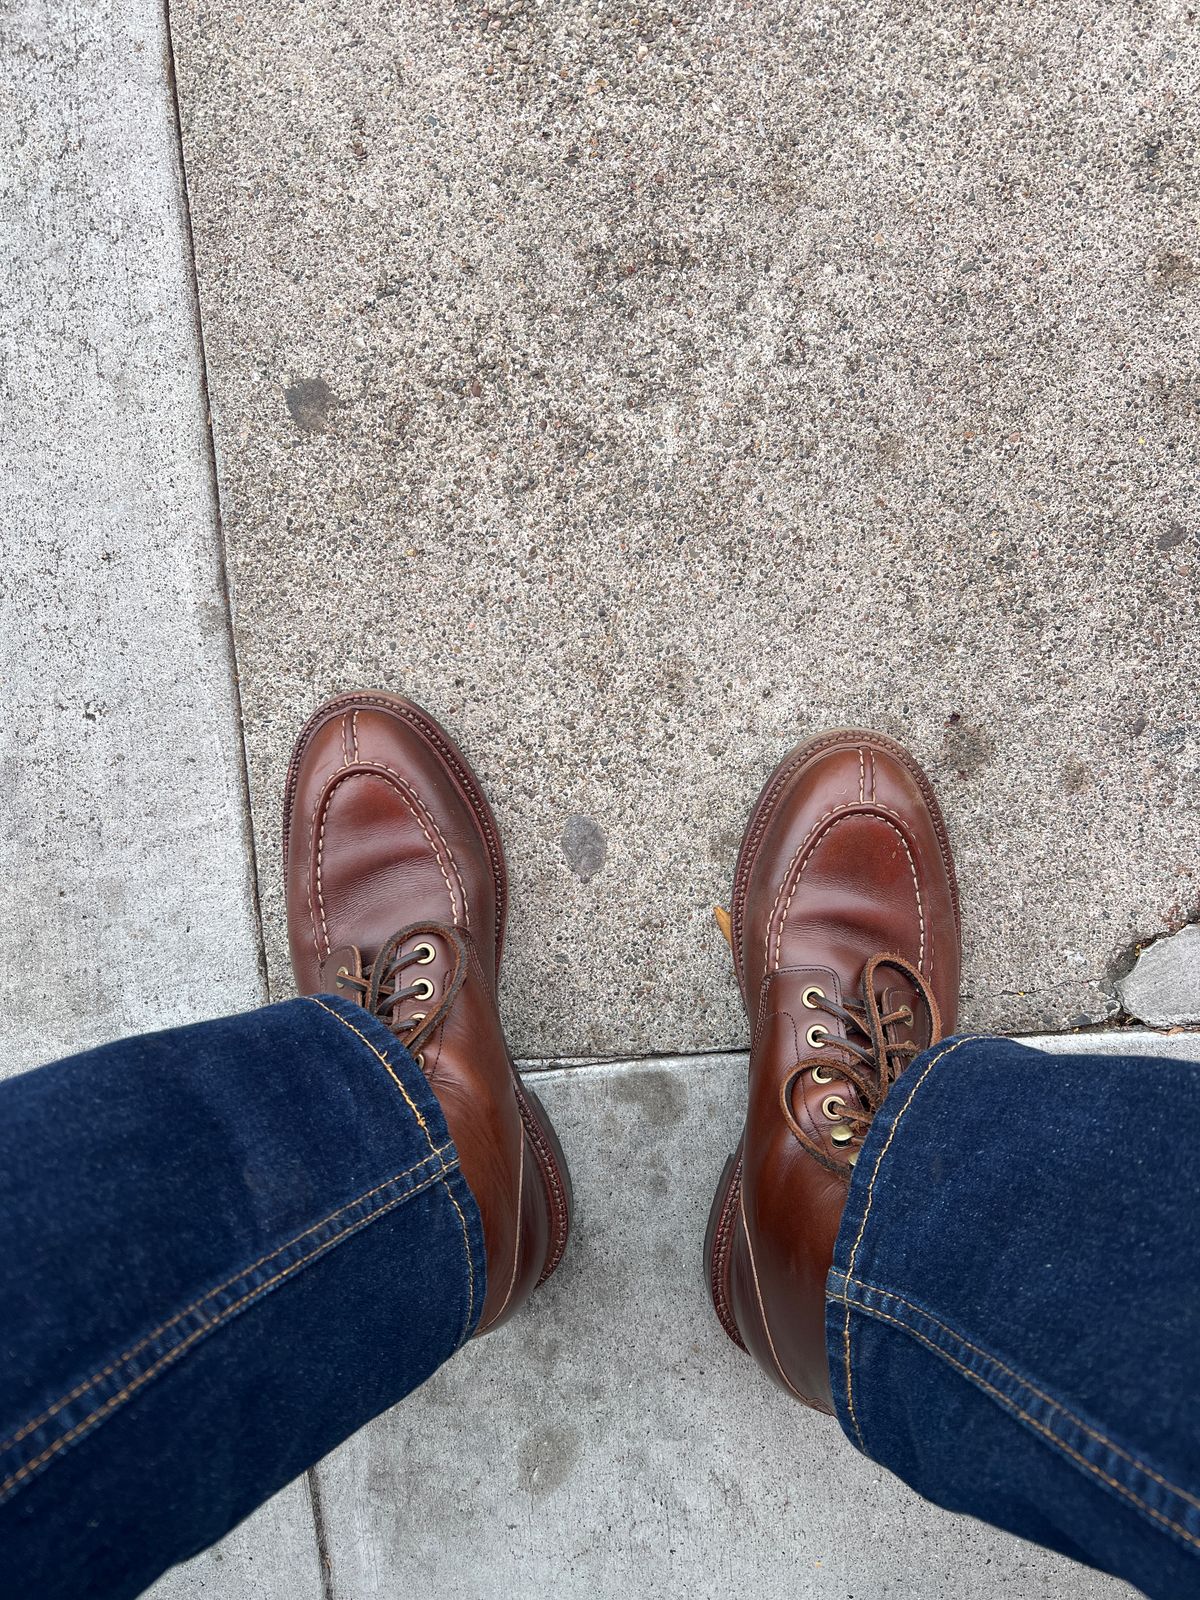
[704,728,962,1350]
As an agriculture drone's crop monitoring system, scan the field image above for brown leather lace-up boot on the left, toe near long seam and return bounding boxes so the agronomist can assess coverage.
[283,693,571,1333]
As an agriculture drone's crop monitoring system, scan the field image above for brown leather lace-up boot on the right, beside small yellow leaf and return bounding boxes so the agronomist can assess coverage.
[706,730,960,1411]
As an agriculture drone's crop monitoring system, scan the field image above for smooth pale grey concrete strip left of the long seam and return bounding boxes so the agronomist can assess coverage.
[0,0,323,1600]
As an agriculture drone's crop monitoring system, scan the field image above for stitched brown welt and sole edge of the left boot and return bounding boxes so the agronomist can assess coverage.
[283,690,574,1286]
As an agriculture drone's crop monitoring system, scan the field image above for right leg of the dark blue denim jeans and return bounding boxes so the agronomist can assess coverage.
[826,1038,1200,1600]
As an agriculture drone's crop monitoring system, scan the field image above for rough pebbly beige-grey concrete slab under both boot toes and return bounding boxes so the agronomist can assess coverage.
[171,0,1200,1056]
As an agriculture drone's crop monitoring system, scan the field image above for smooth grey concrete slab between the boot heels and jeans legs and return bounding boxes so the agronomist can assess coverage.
[317,1035,1200,1600]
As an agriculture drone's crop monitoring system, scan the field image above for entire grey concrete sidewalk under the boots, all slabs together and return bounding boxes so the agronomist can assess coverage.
[0,0,1198,1600]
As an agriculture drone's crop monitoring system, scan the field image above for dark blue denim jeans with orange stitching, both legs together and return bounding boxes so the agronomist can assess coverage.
[0,998,1200,1600]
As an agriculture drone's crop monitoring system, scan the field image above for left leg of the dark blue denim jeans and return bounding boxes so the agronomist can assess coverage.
[0,997,486,1600]
